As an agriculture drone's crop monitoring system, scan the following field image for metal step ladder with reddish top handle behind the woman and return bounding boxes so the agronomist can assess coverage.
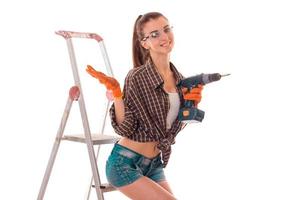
[37,31,120,200]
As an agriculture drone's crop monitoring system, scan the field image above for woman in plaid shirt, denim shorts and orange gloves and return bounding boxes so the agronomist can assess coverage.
[87,12,202,200]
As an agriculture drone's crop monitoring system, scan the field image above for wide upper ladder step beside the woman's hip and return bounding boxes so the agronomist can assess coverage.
[62,134,120,145]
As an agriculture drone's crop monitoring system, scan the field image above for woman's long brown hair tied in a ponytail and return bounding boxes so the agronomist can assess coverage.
[132,12,167,67]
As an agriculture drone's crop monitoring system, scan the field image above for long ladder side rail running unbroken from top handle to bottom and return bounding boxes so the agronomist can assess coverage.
[66,38,104,200]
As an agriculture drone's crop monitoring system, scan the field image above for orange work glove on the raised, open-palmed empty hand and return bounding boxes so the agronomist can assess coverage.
[86,65,122,99]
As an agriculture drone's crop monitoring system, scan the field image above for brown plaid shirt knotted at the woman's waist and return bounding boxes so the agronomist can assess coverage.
[110,61,184,167]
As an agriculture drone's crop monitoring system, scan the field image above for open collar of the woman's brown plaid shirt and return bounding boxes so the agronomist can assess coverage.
[146,59,183,89]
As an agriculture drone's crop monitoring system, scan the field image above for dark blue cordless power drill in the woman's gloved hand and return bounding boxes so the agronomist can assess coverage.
[178,73,230,123]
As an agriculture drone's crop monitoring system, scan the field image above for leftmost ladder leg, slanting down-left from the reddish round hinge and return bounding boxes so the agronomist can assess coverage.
[37,97,73,200]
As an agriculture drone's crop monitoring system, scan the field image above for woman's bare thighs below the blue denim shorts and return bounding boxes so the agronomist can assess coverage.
[117,176,176,200]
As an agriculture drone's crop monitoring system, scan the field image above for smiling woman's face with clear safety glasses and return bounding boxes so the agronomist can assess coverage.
[141,17,174,54]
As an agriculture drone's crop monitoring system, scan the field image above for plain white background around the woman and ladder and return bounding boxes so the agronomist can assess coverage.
[0,0,300,200]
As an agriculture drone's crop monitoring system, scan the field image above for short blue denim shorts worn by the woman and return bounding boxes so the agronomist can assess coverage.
[106,143,166,187]
